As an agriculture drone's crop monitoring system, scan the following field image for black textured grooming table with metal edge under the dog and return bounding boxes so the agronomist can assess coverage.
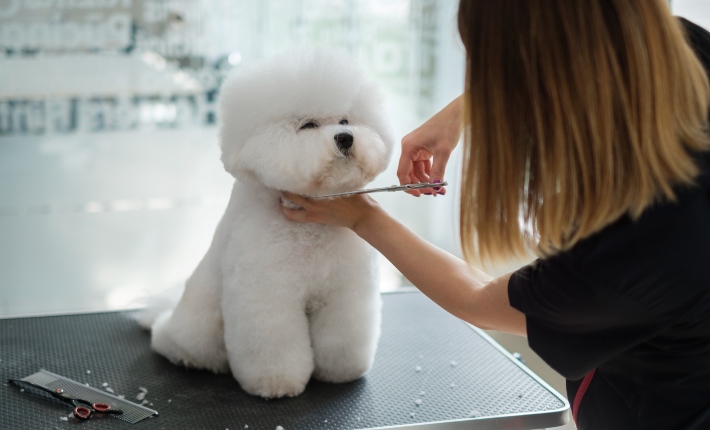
[0,292,569,430]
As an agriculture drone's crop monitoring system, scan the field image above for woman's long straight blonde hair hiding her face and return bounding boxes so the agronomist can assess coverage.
[458,0,710,262]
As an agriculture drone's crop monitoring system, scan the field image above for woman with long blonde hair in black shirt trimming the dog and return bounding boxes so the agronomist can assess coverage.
[283,0,710,430]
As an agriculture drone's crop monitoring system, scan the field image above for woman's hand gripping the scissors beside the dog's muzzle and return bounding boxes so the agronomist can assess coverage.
[397,96,462,197]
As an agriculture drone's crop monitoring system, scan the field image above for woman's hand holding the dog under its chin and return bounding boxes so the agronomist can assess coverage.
[281,191,380,230]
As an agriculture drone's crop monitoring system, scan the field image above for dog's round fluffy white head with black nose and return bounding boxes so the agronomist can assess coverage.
[219,50,393,195]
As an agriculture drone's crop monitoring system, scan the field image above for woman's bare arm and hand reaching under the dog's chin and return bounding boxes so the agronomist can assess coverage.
[282,193,526,335]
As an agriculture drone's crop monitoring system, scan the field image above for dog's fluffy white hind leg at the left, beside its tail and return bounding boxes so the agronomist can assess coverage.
[151,252,229,373]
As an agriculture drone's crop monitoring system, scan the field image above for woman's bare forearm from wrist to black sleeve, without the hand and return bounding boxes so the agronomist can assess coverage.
[353,206,525,334]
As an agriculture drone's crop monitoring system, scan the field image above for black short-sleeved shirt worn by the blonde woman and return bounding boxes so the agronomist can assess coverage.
[508,19,710,430]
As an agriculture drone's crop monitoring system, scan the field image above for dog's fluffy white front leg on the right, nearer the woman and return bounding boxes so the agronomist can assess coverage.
[311,277,382,382]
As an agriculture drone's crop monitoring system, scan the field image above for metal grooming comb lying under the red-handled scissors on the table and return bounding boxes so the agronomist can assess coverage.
[22,369,158,424]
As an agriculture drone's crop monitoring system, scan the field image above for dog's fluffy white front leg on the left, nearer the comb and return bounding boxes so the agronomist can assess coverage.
[222,289,313,398]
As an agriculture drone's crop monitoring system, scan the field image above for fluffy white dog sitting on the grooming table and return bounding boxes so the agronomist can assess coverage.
[144,50,393,398]
